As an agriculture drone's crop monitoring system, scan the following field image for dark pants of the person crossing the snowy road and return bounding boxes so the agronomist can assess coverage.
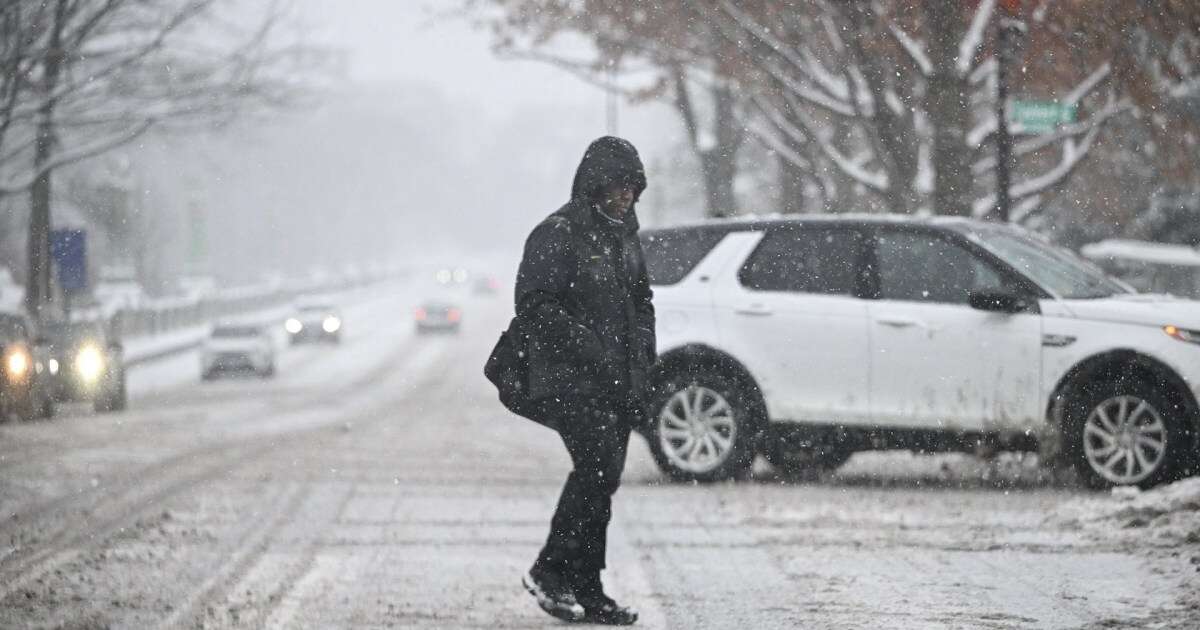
[534,404,630,576]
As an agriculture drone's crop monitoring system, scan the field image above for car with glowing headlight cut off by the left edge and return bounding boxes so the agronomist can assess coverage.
[0,312,54,421]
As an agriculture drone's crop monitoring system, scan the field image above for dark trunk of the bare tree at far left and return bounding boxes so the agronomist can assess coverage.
[25,0,67,320]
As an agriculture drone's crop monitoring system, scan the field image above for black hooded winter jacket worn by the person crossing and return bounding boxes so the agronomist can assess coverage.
[516,137,655,404]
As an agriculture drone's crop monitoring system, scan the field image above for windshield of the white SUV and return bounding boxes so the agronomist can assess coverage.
[970,229,1132,300]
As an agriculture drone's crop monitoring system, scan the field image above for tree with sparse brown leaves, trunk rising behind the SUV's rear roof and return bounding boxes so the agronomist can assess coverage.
[463,0,746,216]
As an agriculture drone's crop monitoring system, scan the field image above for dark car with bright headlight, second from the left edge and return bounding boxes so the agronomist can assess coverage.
[42,322,128,413]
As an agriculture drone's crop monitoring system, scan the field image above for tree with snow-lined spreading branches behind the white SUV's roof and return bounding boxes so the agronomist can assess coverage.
[708,0,1130,220]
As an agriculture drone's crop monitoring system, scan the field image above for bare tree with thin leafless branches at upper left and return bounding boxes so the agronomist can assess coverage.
[0,0,308,313]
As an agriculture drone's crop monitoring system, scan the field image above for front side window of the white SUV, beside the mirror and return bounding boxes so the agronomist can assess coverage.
[875,232,1007,305]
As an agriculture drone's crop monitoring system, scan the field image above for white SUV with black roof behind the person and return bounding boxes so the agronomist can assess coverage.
[642,215,1200,487]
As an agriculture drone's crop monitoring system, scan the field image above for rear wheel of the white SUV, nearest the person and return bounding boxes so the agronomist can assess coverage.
[647,370,761,481]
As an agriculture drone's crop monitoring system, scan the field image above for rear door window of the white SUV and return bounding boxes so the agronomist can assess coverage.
[738,227,862,295]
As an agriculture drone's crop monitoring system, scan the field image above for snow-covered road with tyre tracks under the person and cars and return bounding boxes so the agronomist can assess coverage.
[0,288,1200,630]
